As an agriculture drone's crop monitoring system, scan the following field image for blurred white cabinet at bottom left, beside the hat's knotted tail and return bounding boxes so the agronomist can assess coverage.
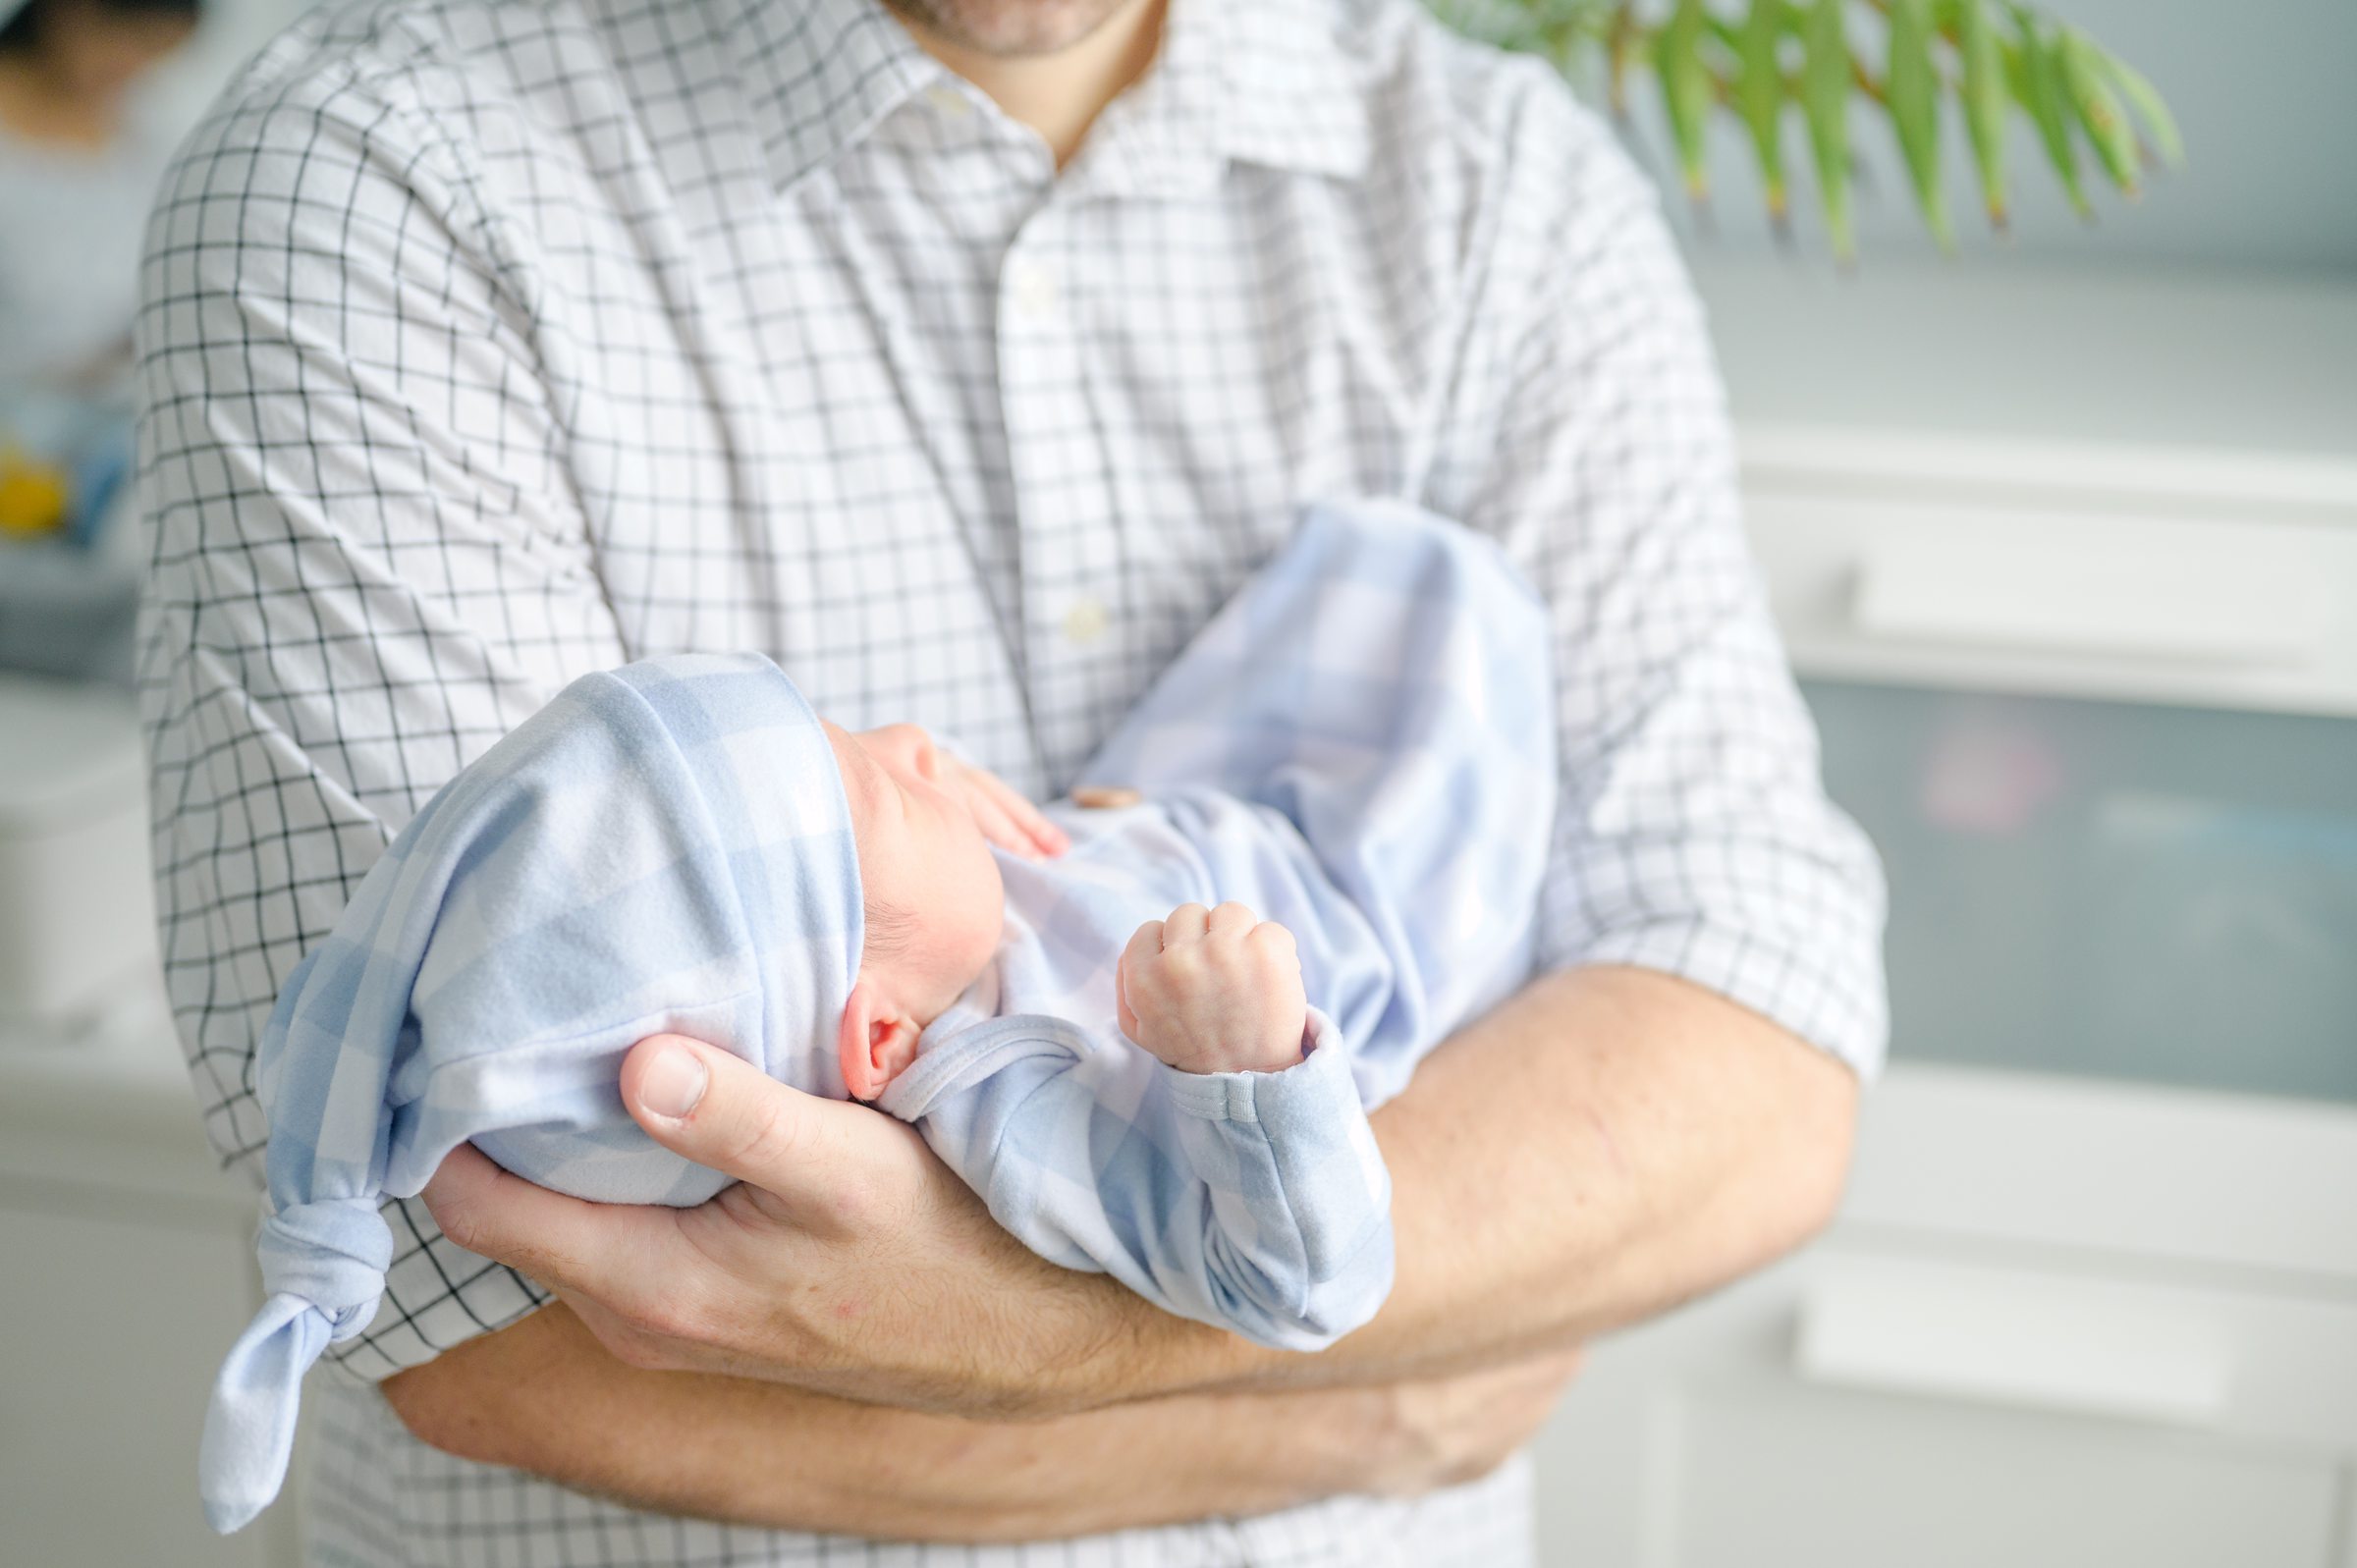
[0,1016,297,1568]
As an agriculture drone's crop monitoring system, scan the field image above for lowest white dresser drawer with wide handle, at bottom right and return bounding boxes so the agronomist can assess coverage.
[1537,1228,2357,1568]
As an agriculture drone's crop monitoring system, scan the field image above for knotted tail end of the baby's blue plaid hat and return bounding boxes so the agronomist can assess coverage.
[195,1198,394,1535]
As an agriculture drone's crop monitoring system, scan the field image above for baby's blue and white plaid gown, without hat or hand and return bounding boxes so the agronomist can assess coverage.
[882,503,1556,1349]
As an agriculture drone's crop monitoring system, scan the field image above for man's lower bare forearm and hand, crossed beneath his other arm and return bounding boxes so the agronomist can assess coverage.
[384,1306,1577,1542]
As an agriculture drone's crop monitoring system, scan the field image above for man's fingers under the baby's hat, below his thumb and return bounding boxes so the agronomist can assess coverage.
[424,1144,677,1290]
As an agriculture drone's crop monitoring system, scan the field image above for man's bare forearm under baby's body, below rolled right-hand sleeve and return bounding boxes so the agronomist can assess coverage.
[1124,969,1857,1393]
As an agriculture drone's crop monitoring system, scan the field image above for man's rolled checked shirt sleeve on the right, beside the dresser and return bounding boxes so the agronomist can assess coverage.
[1433,73,1888,1073]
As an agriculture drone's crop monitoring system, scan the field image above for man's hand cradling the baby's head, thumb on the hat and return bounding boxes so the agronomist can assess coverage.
[424,1035,1178,1415]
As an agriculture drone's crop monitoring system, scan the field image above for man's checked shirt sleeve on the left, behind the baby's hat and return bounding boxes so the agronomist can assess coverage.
[139,55,627,1377]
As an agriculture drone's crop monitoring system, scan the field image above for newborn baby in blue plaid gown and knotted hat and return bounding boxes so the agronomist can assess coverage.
[202,503,1556,1531]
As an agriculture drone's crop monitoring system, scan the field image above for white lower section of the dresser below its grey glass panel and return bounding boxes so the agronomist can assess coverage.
[1537,1065,2357,1568]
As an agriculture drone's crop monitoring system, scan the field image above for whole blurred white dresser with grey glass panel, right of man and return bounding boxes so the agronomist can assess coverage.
[1539,262,2357,1568]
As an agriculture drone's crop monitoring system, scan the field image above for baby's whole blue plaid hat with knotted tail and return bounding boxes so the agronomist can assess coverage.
[202,653,862,1531]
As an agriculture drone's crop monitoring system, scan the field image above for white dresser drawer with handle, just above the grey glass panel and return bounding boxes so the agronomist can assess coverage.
[1744,490,2357,715]
